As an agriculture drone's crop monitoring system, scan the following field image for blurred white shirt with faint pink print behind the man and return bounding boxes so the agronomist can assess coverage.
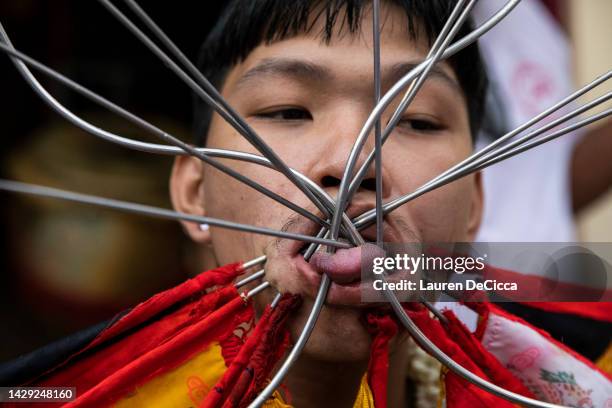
[472,0,577,242]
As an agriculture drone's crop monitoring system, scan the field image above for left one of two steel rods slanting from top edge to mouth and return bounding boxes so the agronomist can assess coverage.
[98,0,330,216]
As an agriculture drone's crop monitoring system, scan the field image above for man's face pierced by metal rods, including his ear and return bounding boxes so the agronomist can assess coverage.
[172,6,481,360]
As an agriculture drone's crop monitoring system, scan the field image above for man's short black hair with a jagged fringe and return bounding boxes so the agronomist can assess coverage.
[194,0,487,145]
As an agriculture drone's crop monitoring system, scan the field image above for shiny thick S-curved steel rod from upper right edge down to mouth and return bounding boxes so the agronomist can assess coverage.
[331,0,520,239]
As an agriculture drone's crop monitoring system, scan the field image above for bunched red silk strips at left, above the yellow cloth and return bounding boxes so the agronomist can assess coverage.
[25,263,246,406]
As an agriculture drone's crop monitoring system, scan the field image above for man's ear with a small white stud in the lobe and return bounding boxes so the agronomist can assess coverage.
[170,156,211,244]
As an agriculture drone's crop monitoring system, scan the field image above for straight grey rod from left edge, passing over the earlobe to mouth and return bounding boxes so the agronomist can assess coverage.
[0,179,351,248]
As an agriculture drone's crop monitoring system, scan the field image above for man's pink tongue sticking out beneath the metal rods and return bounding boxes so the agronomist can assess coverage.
[310,244,384,284]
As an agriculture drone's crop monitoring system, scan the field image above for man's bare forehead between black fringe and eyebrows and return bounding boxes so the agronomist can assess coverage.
[220,2,459,94]
